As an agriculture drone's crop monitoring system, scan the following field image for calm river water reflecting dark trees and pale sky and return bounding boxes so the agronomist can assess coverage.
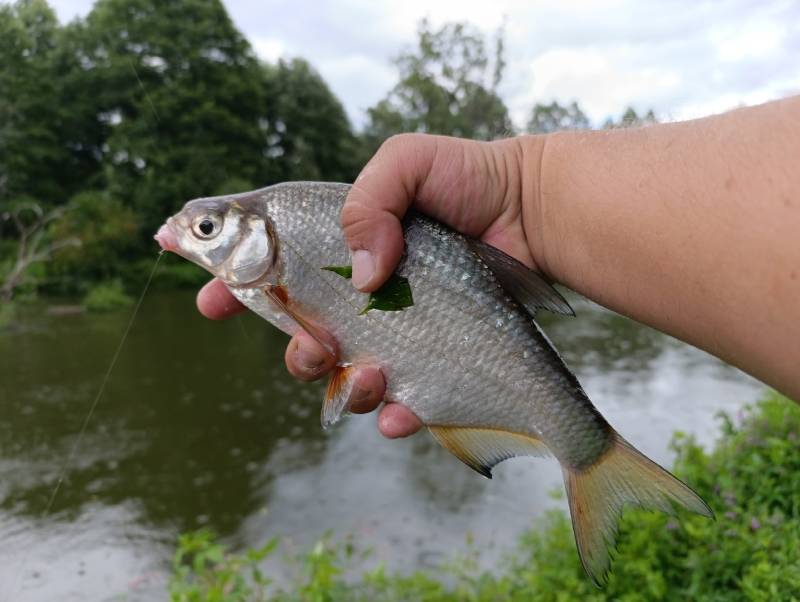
[0,293,762,602]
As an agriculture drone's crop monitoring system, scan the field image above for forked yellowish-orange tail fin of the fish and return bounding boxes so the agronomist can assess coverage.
[563,433,714,585]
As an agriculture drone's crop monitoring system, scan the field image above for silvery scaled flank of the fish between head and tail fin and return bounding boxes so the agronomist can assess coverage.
[268,185,608,465]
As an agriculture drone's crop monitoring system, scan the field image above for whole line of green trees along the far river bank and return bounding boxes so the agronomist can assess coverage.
[0,0,652,292]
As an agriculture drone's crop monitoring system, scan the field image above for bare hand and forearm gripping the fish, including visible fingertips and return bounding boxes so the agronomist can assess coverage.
[197,97,800,437]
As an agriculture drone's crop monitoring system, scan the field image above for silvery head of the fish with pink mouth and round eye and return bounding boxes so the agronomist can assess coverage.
[154,191,277,287]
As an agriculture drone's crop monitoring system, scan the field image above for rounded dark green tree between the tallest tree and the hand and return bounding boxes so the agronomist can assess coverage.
[261,58,361,182]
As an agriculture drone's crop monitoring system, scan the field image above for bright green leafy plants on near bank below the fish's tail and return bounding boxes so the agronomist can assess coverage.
[171,395,800,602]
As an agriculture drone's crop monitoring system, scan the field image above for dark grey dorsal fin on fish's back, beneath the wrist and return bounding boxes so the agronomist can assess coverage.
[469,240,575,317]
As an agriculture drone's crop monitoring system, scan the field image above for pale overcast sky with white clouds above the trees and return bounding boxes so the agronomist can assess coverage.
[45,0,800,126]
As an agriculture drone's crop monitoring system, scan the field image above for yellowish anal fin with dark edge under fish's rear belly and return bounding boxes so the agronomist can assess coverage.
[428,426,550,479]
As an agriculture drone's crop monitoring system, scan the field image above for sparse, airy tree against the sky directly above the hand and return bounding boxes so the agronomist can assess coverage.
[365,20,512,149]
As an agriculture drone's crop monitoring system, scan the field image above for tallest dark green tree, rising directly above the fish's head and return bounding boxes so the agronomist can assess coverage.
[77,0,264,233]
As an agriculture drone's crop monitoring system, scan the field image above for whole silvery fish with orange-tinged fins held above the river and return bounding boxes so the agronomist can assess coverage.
[155,182,713,586]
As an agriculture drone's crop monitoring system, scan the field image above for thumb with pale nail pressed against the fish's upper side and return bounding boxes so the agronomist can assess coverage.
[341,134,437,292]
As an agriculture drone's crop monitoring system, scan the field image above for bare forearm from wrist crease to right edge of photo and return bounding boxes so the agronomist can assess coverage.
[523,98,800,399]
